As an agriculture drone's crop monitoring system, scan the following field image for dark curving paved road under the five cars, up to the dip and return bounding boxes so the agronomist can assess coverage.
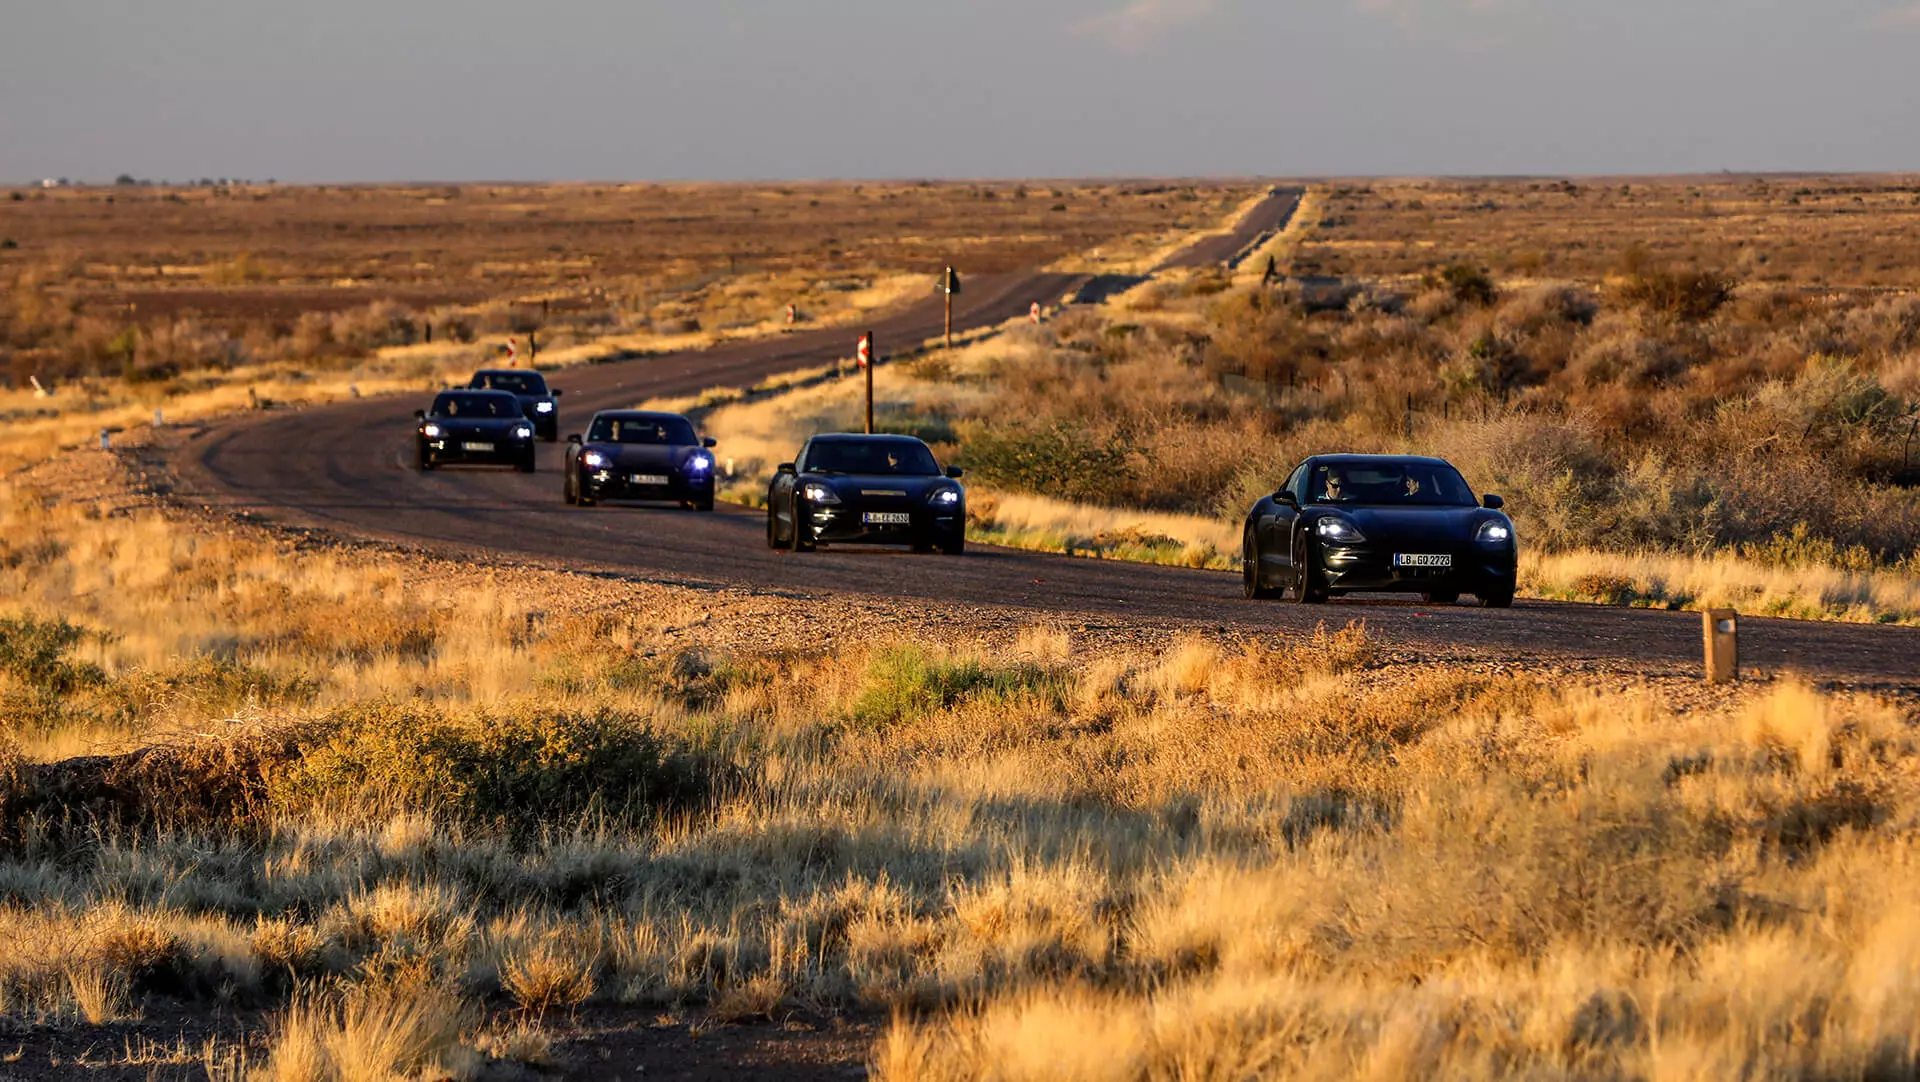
[177,191,1920,687]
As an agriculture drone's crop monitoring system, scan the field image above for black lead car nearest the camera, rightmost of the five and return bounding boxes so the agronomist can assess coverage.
[1240,455,1517,608]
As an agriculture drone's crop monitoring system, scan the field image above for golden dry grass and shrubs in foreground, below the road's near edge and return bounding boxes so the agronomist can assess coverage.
[0,487,1920,1080]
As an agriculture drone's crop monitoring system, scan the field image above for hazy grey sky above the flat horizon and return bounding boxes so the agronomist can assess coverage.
[0,0,1920,180]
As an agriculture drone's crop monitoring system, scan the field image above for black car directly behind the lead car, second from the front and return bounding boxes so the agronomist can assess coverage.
[766,435,966,556]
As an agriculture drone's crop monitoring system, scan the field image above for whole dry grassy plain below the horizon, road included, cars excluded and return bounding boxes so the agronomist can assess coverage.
[0,176,1920,1082]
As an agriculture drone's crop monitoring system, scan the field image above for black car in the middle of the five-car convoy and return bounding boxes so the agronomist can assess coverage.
[566,409,716,510]
